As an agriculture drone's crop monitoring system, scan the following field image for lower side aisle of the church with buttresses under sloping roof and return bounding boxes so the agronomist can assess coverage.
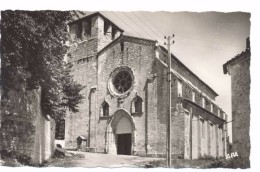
[180,98,226,159]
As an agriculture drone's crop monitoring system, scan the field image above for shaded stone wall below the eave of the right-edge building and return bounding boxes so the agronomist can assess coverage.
[231,54,250,168]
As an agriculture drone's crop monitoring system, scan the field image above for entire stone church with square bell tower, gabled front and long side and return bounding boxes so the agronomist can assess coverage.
[65,12,227,159]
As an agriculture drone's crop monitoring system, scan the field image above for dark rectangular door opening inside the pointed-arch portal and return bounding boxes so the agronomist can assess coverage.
[117,133,132,155]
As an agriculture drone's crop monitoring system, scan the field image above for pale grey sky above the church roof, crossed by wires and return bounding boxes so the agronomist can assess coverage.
[80,11,251,138]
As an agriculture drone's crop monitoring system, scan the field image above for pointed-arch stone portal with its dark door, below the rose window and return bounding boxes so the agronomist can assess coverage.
[106,109,135,155]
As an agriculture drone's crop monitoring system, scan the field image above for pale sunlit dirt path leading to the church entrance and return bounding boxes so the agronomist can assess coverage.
[65,151,163,167]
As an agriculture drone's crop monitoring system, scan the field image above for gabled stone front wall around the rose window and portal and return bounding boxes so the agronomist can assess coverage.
[96,37,157,155]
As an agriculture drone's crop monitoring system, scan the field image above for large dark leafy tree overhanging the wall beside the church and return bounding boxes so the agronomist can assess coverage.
[1,11,83,119]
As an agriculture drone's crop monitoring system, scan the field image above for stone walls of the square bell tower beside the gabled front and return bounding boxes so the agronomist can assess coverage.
[65,15,120,149]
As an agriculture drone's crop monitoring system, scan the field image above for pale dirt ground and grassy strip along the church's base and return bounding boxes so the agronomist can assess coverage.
[40,151,232,169]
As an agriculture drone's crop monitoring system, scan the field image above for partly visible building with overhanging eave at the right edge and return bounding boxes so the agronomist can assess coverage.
[223,38,251,168]
